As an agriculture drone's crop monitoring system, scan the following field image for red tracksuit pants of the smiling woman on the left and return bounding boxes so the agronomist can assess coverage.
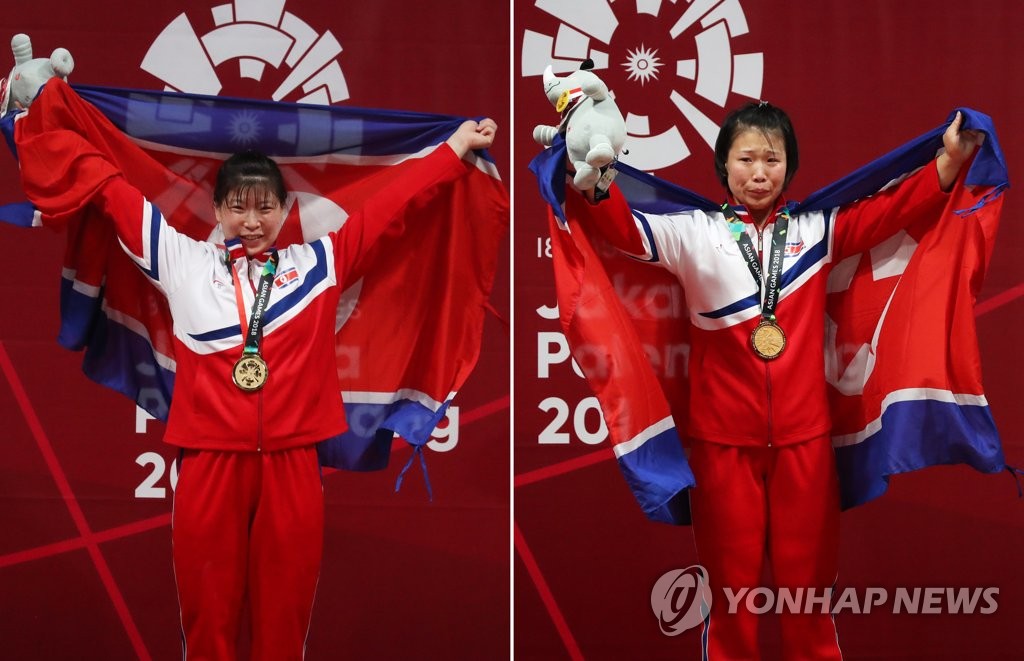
[171,446,324,661]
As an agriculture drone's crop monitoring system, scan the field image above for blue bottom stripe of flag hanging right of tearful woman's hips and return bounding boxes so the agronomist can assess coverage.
[836,399,1006,510]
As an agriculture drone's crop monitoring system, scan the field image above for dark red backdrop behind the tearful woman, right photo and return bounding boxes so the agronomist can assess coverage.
[513,0,1024,659]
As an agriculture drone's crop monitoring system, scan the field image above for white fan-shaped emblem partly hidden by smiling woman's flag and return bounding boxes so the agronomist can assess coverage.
[141,0,348,104]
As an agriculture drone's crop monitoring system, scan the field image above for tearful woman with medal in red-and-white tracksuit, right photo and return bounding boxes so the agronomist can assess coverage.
[566,102,982,660]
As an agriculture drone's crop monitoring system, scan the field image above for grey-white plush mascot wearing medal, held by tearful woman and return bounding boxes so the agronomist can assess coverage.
[534,59,626,190]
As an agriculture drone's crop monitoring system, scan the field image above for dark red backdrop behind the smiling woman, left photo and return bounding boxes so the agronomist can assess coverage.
[0,0,511,659]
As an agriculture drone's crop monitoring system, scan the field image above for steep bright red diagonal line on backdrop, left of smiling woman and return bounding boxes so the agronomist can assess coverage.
[0,342,151,661]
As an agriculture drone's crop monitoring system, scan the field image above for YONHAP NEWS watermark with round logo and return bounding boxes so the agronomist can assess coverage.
[650,565,999,635]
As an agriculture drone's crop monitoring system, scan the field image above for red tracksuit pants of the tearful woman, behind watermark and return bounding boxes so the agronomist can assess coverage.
[689,437,842,661]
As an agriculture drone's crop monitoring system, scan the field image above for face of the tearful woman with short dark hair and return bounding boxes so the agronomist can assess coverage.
[725,129,785,221]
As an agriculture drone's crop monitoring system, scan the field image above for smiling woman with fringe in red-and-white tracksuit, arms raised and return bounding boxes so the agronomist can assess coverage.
[16,81,497,659]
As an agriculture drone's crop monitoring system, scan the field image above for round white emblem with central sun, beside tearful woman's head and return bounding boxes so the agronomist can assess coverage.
[520,0,764,171]
